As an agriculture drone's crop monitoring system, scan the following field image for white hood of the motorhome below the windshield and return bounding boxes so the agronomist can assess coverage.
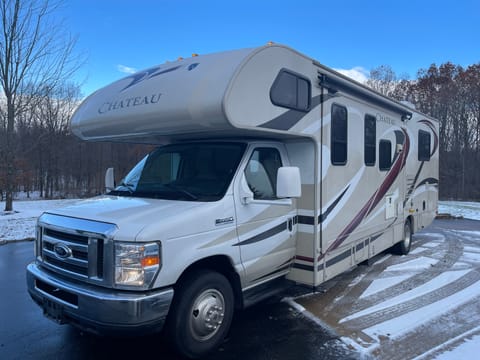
[48,196,233,241]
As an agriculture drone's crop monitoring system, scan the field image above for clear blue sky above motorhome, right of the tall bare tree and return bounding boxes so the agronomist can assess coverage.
[60,0,480,95]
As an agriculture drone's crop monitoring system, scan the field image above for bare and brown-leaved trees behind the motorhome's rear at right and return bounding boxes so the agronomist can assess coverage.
[367,62,480,200]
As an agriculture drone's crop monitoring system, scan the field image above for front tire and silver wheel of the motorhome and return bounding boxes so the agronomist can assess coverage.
[167,271,234,358]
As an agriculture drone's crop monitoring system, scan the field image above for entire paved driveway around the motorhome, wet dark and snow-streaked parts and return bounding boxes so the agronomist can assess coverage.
[0,220,480,360]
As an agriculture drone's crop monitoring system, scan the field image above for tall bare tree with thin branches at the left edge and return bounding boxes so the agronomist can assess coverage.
[0,0,80,211]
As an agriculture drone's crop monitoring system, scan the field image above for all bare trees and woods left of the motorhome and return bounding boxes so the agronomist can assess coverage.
[0,0,152,207]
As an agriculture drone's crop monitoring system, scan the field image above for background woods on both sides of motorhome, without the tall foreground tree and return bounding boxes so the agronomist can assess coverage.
[0,63,480,204]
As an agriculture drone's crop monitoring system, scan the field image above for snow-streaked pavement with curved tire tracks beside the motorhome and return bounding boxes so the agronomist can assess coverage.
[295,220,480,359]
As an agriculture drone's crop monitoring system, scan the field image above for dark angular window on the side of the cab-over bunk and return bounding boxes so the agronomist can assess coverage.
[270,70,311,111]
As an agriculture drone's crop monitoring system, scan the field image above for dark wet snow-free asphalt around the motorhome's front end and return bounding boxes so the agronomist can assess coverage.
[0,242,358,360]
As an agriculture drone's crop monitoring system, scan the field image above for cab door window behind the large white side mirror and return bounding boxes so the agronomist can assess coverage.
[245,148,282,200]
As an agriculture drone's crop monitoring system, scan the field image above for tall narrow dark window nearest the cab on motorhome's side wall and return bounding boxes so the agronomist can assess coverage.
[330,104,348,165]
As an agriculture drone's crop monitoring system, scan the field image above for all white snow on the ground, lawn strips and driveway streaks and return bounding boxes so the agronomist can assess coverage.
[0,200,480,360]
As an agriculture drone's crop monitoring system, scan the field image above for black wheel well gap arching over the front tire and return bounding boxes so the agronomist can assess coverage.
[175,255,243,309]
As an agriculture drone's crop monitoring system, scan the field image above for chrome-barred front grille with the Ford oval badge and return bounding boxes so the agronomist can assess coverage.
[39,225,104,280]
